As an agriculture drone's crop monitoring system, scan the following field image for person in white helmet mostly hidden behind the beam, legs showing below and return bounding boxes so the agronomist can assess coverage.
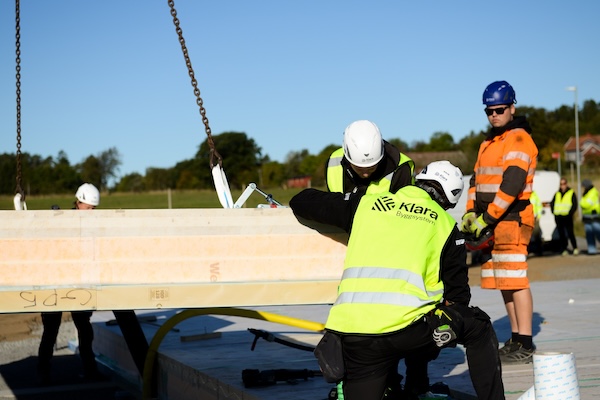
[37,183,104,385]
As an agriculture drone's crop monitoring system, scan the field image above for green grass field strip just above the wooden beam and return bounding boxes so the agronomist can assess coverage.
[0,189,310,210]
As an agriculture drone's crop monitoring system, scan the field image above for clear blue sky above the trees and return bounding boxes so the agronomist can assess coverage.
[0,0,600,180]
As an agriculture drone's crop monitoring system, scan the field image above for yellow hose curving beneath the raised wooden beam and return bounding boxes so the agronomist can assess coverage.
[142,307,325,400]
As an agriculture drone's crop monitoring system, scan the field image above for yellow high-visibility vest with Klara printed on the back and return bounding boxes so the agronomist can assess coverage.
[325,186,456,334]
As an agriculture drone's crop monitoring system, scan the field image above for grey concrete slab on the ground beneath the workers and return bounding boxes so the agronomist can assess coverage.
[93,279,600,400]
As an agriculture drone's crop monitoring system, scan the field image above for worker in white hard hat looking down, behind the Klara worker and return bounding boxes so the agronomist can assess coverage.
[325,120,415,193]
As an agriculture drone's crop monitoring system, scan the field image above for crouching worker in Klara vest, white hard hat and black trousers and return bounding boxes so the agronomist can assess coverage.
[290,161,504,400]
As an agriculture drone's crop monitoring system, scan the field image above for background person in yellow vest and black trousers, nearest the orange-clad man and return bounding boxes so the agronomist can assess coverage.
[550,178,579,256]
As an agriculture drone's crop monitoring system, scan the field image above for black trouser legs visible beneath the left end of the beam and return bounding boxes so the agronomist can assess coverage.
[38,311,97,377]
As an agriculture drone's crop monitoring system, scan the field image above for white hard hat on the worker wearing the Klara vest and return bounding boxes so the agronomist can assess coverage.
[415,161,464,209]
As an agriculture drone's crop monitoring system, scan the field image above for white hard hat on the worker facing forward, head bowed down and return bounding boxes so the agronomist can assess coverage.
[344,120,384,168]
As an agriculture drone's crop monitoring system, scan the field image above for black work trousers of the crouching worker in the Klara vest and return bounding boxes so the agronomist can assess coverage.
[342,316,505,400]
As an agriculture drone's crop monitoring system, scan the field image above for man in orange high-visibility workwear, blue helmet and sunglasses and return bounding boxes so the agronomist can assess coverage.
[461,81,538,364]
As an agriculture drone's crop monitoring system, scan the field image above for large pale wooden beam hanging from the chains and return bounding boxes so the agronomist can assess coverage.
[0,208,347,313]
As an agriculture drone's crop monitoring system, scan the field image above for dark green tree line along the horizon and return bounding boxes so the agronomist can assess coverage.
[0,100,600,195]
